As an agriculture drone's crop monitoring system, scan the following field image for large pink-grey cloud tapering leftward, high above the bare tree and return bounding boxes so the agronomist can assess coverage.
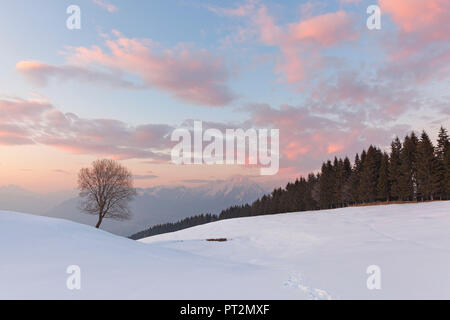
[70,37,234,106]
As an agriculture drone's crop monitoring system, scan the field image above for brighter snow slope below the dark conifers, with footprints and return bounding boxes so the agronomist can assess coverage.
[142,201,450,299]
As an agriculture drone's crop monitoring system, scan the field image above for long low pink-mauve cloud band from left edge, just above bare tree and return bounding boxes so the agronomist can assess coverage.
[0,99,173,161]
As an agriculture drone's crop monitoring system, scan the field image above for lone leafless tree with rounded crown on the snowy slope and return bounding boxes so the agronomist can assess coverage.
[78,159,136,228]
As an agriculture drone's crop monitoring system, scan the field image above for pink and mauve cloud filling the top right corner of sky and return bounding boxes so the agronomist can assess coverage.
[379,0,450,86]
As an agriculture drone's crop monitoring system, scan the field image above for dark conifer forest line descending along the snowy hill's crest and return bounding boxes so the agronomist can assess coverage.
[131,127,450,239]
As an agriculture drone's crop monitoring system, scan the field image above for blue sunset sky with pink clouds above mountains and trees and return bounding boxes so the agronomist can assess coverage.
[0,0,450,192]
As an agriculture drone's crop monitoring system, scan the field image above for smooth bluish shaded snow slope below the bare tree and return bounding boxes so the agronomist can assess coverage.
[0,212,298,299]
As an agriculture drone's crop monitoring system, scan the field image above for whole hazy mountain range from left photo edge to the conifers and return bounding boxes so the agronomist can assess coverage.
[0,176,270,236]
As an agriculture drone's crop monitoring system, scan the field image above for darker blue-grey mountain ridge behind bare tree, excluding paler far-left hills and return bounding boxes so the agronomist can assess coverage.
[44,177,268,236]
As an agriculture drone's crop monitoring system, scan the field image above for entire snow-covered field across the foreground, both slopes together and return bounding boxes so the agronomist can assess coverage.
[0,201,450,299]
